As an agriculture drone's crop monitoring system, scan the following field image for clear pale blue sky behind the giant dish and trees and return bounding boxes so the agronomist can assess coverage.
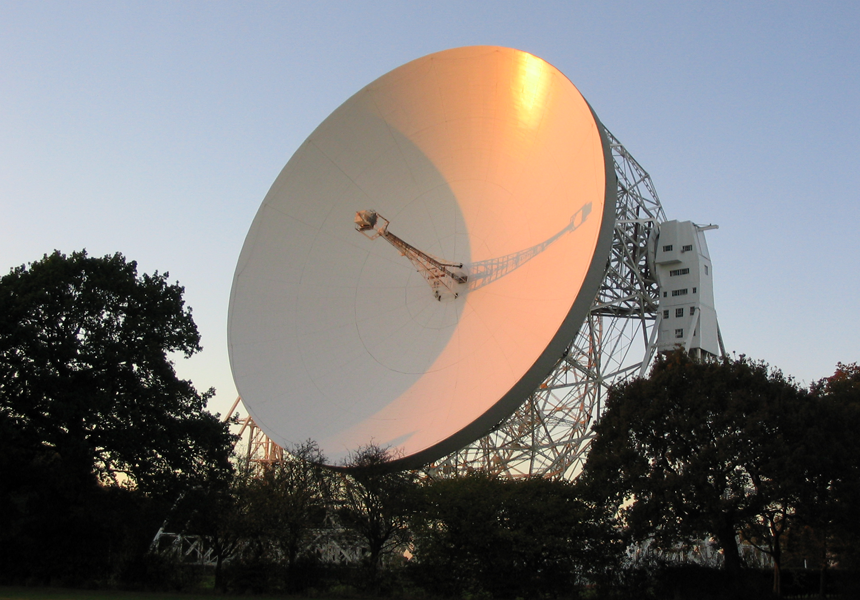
[0,0,860,412]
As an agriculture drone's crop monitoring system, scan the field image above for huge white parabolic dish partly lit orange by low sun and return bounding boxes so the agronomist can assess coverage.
[228,46,615,467]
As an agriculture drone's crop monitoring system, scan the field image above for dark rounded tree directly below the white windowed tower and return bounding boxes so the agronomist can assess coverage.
[583,352,805,590]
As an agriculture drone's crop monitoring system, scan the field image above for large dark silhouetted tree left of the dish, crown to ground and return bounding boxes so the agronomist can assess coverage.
[0,252,232,582]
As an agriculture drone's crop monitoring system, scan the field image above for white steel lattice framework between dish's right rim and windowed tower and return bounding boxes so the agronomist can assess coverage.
[428,130,666,478]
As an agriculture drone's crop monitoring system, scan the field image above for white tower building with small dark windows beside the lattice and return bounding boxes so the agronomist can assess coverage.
[649,221,725,359]
